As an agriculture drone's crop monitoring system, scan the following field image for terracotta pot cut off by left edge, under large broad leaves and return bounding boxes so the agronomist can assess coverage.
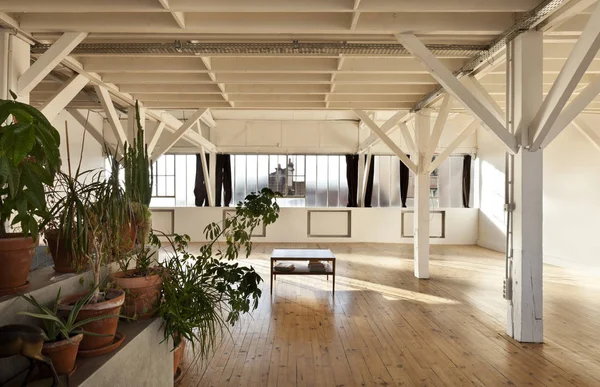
[0,234,38,295]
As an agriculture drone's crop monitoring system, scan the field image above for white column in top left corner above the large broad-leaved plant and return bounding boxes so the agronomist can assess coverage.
[0,29,31,103]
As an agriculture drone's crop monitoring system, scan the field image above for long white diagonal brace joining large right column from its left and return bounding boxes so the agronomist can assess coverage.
[397,34,519,154]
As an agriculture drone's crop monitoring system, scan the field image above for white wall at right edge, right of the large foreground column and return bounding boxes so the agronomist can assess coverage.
[544,115,600,268]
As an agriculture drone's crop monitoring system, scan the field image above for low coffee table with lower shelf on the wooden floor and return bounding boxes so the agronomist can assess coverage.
[270,249,335,295]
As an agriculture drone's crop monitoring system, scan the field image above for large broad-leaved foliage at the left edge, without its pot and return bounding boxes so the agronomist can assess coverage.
[0,92,61,239]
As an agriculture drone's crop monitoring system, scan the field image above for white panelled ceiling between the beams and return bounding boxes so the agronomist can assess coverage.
[0,0,600,115]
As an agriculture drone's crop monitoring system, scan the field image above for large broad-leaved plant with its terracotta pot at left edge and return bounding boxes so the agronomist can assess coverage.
[0,92,60,295]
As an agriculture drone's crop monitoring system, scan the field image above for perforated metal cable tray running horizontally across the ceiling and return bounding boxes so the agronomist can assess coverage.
[31,41,488,57]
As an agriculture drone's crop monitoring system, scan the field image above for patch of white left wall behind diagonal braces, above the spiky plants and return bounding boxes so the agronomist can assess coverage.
[52,110,104,175]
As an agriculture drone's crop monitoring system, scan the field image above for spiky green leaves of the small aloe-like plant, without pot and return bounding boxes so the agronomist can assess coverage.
[18,289,117,342]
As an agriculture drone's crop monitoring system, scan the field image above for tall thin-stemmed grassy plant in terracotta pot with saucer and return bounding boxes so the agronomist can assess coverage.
[58,163,131,356]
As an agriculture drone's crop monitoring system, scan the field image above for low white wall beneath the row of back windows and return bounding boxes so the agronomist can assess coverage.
[152,207,478,245]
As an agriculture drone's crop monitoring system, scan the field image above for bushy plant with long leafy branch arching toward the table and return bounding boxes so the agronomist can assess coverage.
[159,188,279,382]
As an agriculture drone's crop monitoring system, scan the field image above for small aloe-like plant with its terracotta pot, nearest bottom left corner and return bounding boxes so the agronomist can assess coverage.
[18,289,118,375]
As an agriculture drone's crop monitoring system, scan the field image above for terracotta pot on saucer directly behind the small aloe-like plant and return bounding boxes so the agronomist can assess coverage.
[58,289,125,350]
